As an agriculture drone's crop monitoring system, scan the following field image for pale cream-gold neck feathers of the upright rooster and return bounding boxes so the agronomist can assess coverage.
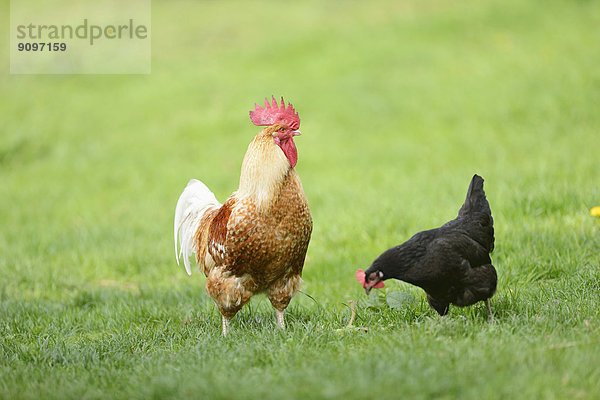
[235,130,291,211]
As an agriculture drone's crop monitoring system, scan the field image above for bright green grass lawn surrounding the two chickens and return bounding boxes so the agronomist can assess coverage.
[0,0,600,399]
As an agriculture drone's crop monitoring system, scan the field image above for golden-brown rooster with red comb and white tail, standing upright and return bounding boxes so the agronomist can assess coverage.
[174,97,312,335]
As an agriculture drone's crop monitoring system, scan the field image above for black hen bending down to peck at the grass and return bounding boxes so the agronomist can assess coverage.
[365,175,498,318]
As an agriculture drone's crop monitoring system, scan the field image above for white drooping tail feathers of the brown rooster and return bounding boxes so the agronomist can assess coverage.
[173,179,221,275]
